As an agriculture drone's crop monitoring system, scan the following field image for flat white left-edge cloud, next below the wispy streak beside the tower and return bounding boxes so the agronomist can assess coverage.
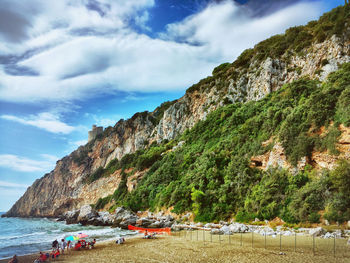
[0,154,55,172]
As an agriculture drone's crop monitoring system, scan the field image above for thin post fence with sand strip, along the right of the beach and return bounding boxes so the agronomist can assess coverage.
[172,230,350,262]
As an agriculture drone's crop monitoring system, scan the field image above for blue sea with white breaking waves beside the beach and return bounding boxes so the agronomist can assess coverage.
[0,212,136,259]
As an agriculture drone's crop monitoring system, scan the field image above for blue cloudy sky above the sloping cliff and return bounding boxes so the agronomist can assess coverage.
[0,0,344,211]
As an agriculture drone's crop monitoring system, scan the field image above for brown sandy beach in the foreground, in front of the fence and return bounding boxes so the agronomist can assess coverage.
[0,233,350,263]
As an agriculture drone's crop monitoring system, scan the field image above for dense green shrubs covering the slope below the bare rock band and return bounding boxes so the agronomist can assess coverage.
[91,64,350,223]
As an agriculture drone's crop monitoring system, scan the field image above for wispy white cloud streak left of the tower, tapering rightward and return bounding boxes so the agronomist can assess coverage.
[0,112,75,134]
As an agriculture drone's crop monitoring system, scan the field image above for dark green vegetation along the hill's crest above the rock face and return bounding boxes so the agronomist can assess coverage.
[186,5,350,93]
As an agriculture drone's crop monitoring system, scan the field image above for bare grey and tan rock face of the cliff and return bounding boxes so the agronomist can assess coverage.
[7,9,350,217]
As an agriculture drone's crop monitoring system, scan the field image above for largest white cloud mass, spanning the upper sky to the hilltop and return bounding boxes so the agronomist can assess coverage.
[0,0,321,103]
